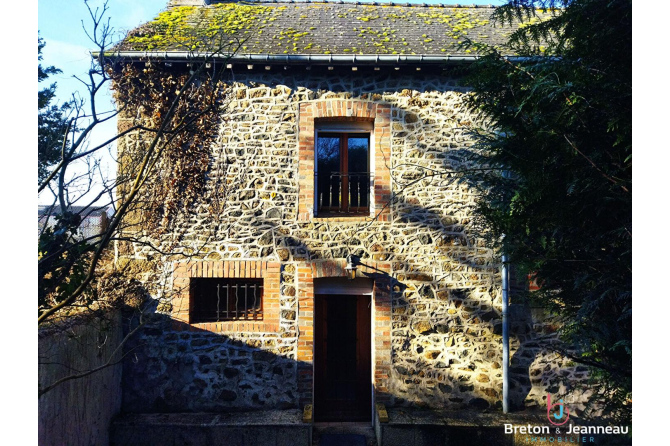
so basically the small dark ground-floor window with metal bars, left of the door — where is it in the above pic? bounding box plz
[191,278,263,323]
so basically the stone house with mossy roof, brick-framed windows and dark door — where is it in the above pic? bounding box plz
[114,0,586,420]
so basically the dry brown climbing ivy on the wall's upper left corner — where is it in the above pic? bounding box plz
[113,63,229,233]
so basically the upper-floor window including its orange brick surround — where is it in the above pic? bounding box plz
[296,103,391,222]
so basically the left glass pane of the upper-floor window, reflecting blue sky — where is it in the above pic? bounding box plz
[316,136,341,207]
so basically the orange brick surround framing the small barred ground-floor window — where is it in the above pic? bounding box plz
[172,260,280,333]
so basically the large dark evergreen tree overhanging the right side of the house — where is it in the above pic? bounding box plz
[469,0,632,419]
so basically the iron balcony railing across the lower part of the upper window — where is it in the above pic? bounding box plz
[316,172,371,214]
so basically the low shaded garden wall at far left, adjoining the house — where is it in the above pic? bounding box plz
[38,314,123,446]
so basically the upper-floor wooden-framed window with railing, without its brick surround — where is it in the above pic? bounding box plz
[315,122,371,217]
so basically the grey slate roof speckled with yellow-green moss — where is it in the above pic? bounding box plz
[115,0,552,56]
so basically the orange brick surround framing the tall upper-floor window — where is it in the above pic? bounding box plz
[298,99,391,221]
